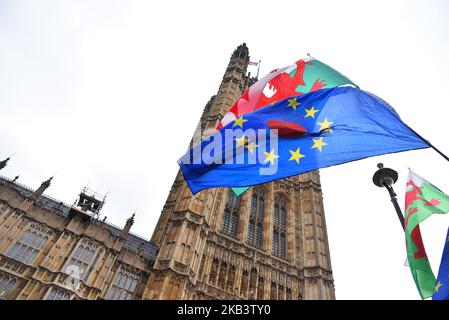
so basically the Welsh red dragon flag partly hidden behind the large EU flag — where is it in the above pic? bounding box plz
[217,58,356,195]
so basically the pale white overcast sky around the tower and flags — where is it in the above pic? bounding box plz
[0,0,449,299]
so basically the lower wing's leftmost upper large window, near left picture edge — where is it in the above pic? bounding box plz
[6,225,48,264]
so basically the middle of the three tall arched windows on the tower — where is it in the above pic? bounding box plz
[247,188,265,247]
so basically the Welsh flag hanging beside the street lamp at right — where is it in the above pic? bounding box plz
[405,170,449,299]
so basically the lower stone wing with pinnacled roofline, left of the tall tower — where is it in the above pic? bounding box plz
[0,172,157,300]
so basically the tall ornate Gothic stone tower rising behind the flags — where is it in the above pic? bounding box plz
[144,44,335,299]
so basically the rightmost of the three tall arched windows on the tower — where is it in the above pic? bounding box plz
[272,196,287,259]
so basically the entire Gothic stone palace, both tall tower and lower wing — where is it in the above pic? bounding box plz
[0,44,335,300]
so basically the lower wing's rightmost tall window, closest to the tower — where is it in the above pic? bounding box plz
[107,266,139,300]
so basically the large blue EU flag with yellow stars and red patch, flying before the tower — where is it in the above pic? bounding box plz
[178,87,429,194]
